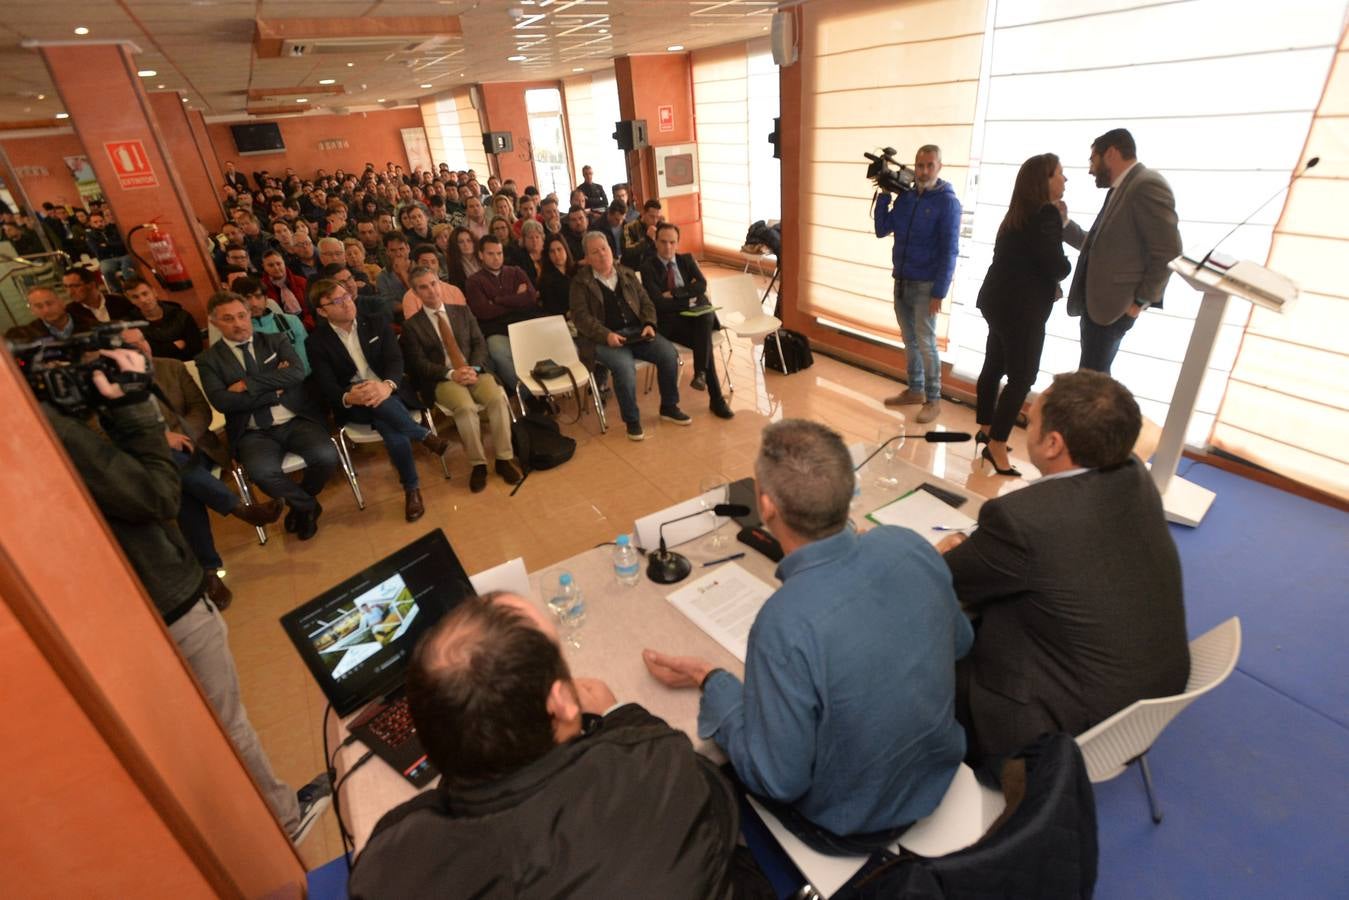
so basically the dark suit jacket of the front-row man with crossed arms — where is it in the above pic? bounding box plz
[197,332,324,452]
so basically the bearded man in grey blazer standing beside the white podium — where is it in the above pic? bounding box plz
[1059,128,1180,375]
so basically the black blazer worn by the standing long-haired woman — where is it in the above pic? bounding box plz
[977,204,1070,324]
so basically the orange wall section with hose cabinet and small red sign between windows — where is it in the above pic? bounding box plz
[614,53,703,256]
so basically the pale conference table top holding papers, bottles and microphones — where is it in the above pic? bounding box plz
[324,445,983,853]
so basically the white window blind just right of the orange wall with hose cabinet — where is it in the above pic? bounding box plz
[692,40,782,254]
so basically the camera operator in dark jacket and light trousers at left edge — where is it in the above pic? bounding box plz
[40,348,329,843]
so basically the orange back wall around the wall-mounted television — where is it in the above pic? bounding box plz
[206,107,422,184]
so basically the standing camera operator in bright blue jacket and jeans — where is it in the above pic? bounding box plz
[876,144,960,424]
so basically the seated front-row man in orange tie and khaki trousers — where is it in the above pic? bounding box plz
[399,266,523,494]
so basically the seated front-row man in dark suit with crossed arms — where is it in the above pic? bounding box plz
[197,291,337,541]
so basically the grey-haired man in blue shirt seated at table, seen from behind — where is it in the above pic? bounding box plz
[642,420,974,853]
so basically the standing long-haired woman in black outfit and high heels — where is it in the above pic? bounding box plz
[974,152,1070,476]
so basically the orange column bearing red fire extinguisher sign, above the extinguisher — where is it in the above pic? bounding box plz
[39,43,217,322]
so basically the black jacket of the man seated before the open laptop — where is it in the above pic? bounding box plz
[348,704,739,900]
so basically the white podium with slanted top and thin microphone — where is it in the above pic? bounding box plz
[1152,256,1298,528]
